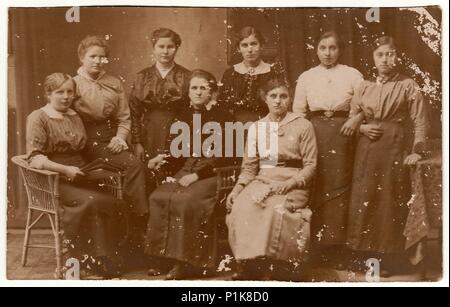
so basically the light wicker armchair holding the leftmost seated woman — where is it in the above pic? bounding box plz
[11,155,123,278]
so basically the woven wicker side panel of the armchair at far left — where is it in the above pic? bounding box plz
[11,155,59,214]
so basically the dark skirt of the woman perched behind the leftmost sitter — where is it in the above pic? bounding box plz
[83,121,148,216]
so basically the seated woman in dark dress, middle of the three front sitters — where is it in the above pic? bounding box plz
[145,70,225,279]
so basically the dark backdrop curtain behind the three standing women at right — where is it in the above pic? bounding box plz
[228,6,442,138]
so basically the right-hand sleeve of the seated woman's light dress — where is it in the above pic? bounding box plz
[293,120,317,188]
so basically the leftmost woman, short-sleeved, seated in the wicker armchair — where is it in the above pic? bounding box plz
[26,73,124,277]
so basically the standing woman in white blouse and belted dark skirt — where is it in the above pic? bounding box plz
[293,31,363,268]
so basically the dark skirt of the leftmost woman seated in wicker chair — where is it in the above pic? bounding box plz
[59,181,125,257]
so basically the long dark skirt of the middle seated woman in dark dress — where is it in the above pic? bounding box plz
[145,169,216,268]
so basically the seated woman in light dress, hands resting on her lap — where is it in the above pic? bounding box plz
[227,80,317,279]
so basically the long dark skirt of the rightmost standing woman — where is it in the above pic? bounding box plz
[348,122,411,253]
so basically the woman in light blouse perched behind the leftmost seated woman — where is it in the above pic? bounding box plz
[74,36,148,248]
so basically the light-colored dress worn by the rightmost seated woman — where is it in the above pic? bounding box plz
[226,113,317,261]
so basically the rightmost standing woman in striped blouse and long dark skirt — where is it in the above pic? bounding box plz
[348,36,427,275]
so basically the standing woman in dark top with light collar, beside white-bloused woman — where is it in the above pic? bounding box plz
[218,26,285,123]
